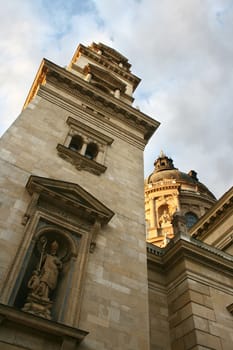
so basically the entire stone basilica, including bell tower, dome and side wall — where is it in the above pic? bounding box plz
[0,43,233,350]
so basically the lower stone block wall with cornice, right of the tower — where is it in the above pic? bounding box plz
[149,237,233,350]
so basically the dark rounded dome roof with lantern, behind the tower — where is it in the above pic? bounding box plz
[145,152,216,199]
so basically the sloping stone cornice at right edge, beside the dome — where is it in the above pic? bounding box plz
[189,187,233,239]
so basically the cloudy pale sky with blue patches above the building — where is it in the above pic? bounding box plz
[0,0,233,197]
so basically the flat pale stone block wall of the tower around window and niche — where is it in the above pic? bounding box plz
[0,85,149,350]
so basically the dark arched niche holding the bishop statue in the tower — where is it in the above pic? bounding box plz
[14,225,80,320]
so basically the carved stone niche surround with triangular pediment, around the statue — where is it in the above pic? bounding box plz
[1,176,114,326]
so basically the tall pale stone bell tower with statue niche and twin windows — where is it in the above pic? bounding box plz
[0,43,159,350]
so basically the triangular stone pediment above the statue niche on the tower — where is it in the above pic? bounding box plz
[26,175,114,224]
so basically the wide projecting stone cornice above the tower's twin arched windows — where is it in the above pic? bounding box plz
[24,59,160,141]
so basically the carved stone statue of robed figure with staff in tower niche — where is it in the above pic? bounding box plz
[22,237,62,319]
